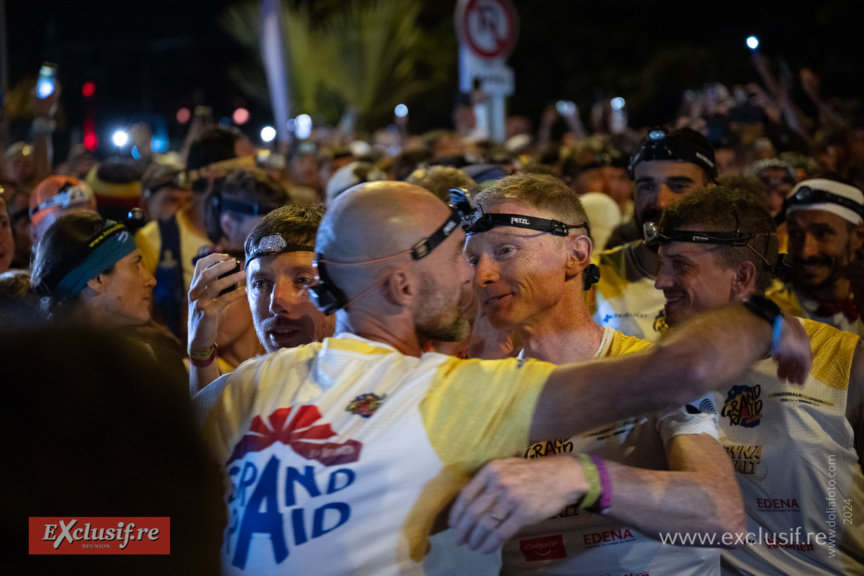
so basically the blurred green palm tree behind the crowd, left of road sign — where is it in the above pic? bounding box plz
[222,0,452,129]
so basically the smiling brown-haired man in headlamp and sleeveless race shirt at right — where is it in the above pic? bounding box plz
[655,187,864,576]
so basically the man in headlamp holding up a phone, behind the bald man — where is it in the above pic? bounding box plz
[189,205,335,394]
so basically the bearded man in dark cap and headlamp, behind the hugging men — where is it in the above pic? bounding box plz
[591,128,717,340]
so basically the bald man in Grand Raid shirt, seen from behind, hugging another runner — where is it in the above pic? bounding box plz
[195,182,810,575]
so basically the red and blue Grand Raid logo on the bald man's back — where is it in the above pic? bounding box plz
[225,406,363,569]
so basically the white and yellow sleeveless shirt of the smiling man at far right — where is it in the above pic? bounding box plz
[717,320,864,576]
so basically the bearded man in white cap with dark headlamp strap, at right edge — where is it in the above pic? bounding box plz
[767,178,864,336]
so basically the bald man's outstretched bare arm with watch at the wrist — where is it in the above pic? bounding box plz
[530,305,812,438]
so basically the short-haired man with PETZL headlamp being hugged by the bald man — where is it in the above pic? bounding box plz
[465,174,744,576]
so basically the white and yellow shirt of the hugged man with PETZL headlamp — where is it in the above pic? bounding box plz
[501,328,720,576]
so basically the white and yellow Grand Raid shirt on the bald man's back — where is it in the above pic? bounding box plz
[194,334,554,576]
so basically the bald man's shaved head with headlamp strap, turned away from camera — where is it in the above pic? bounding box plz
[316,181,471,340]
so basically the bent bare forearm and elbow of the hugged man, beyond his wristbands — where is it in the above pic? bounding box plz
[606,434,747,547]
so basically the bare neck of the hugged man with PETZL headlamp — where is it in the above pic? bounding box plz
[516,294,604,364]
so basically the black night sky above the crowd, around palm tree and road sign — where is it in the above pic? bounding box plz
[5,0,864,152]
